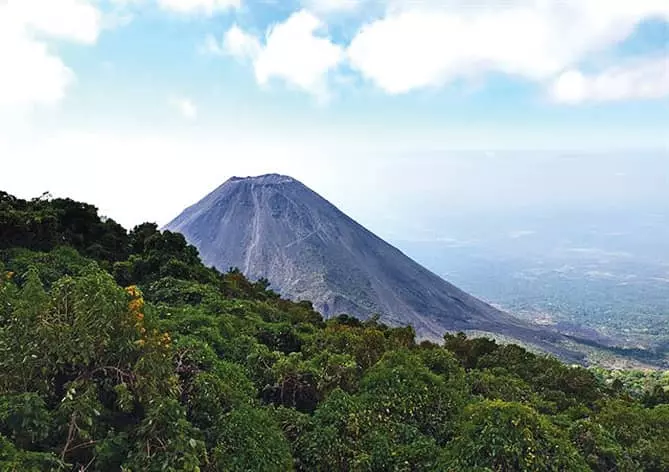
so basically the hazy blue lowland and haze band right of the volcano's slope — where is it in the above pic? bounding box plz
[326,150,669,364]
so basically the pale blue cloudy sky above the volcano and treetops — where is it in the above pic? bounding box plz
[0,0,669,231]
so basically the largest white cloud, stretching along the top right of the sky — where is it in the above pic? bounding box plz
[347,0,669,94]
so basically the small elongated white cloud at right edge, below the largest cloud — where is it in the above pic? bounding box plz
[550,57,669,104]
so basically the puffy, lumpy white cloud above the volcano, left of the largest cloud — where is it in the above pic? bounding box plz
[223,10,344,98]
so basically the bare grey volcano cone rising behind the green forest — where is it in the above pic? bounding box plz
[165,174,576,353]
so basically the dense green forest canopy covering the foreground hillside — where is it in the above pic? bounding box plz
[0,193,669,472]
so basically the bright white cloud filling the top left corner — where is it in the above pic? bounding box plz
[0,0,101,111]
